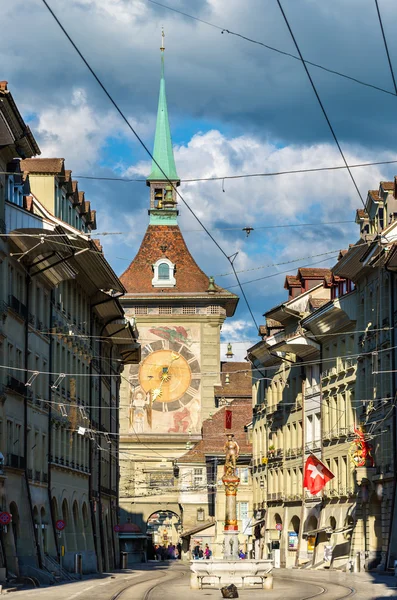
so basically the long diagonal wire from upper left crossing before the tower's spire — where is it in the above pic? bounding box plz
[42,0,258,329]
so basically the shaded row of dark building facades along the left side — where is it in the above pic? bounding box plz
[0,84,139,582]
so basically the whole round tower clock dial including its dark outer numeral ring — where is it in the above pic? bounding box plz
[138,341,200,412]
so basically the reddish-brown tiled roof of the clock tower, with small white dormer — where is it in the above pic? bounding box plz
[120,225,237,301]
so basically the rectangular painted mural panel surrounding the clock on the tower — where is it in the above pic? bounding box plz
[124,323,201,434]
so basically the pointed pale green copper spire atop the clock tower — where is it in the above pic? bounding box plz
[147,44,179,181]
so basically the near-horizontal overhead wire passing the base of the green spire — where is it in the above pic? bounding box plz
[0,160,397,183]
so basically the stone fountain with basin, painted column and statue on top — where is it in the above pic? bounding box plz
[190,433,273,589]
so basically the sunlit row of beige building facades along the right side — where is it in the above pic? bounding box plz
[249,182,397,569]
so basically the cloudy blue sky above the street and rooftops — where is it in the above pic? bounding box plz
[0,0,397,359]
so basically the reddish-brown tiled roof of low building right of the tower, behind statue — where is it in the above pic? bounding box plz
[178,398,252,463]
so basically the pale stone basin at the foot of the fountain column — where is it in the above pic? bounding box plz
[190,559,273,590]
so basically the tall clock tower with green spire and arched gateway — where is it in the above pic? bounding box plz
[119,38,238,544]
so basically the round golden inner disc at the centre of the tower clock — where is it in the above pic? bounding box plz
[138,349,192,410]
